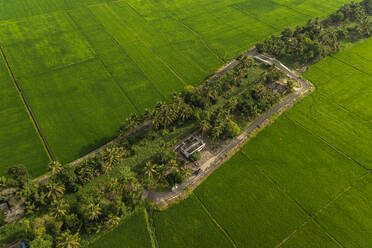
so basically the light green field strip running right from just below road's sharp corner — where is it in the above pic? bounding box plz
[287,91,372,168]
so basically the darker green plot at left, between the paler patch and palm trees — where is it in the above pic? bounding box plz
[17,59,134,162]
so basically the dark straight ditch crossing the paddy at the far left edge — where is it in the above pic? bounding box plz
[0,45,55,161]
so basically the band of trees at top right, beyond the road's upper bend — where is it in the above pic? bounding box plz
[256,0,372,64]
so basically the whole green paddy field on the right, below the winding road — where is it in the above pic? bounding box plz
[91,36,372,248]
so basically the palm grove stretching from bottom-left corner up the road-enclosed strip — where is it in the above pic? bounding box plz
[0,43,283,248]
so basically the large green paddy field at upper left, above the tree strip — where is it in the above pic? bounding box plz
[0,0,358,176]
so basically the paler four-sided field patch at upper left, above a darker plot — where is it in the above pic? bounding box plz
[0,12,94,78]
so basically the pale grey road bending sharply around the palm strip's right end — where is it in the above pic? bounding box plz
[147,48,311,205]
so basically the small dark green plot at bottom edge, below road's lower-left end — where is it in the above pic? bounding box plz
[153,195,232,248]
